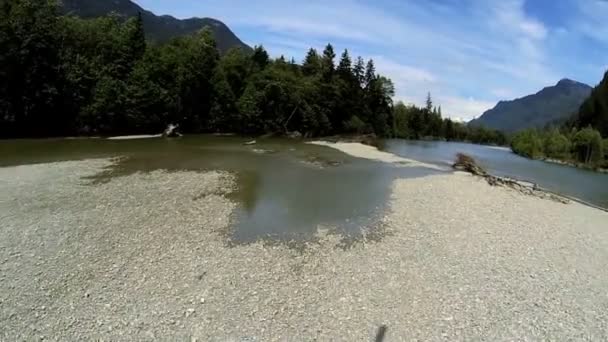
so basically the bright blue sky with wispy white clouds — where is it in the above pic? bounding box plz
[135,0,608,121]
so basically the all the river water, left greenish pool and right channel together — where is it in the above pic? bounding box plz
[0,136,608,243]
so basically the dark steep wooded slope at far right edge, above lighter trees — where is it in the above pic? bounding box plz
[574,71,608,138]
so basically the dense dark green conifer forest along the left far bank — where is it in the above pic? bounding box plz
[0,0,506,144]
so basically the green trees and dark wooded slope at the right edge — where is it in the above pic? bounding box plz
[511,72,608,168]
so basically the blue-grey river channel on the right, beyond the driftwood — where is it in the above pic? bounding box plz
[383,140,608,208]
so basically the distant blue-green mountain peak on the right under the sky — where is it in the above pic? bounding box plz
[469,79,592,133]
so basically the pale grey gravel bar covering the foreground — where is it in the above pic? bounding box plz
[0,160,608,341]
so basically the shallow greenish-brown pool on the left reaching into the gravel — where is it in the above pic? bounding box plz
[0,136,431,242]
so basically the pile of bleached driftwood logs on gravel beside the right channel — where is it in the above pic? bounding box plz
[452,153,570,204]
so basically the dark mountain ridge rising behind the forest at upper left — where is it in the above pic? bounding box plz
[62,0,251,52]
